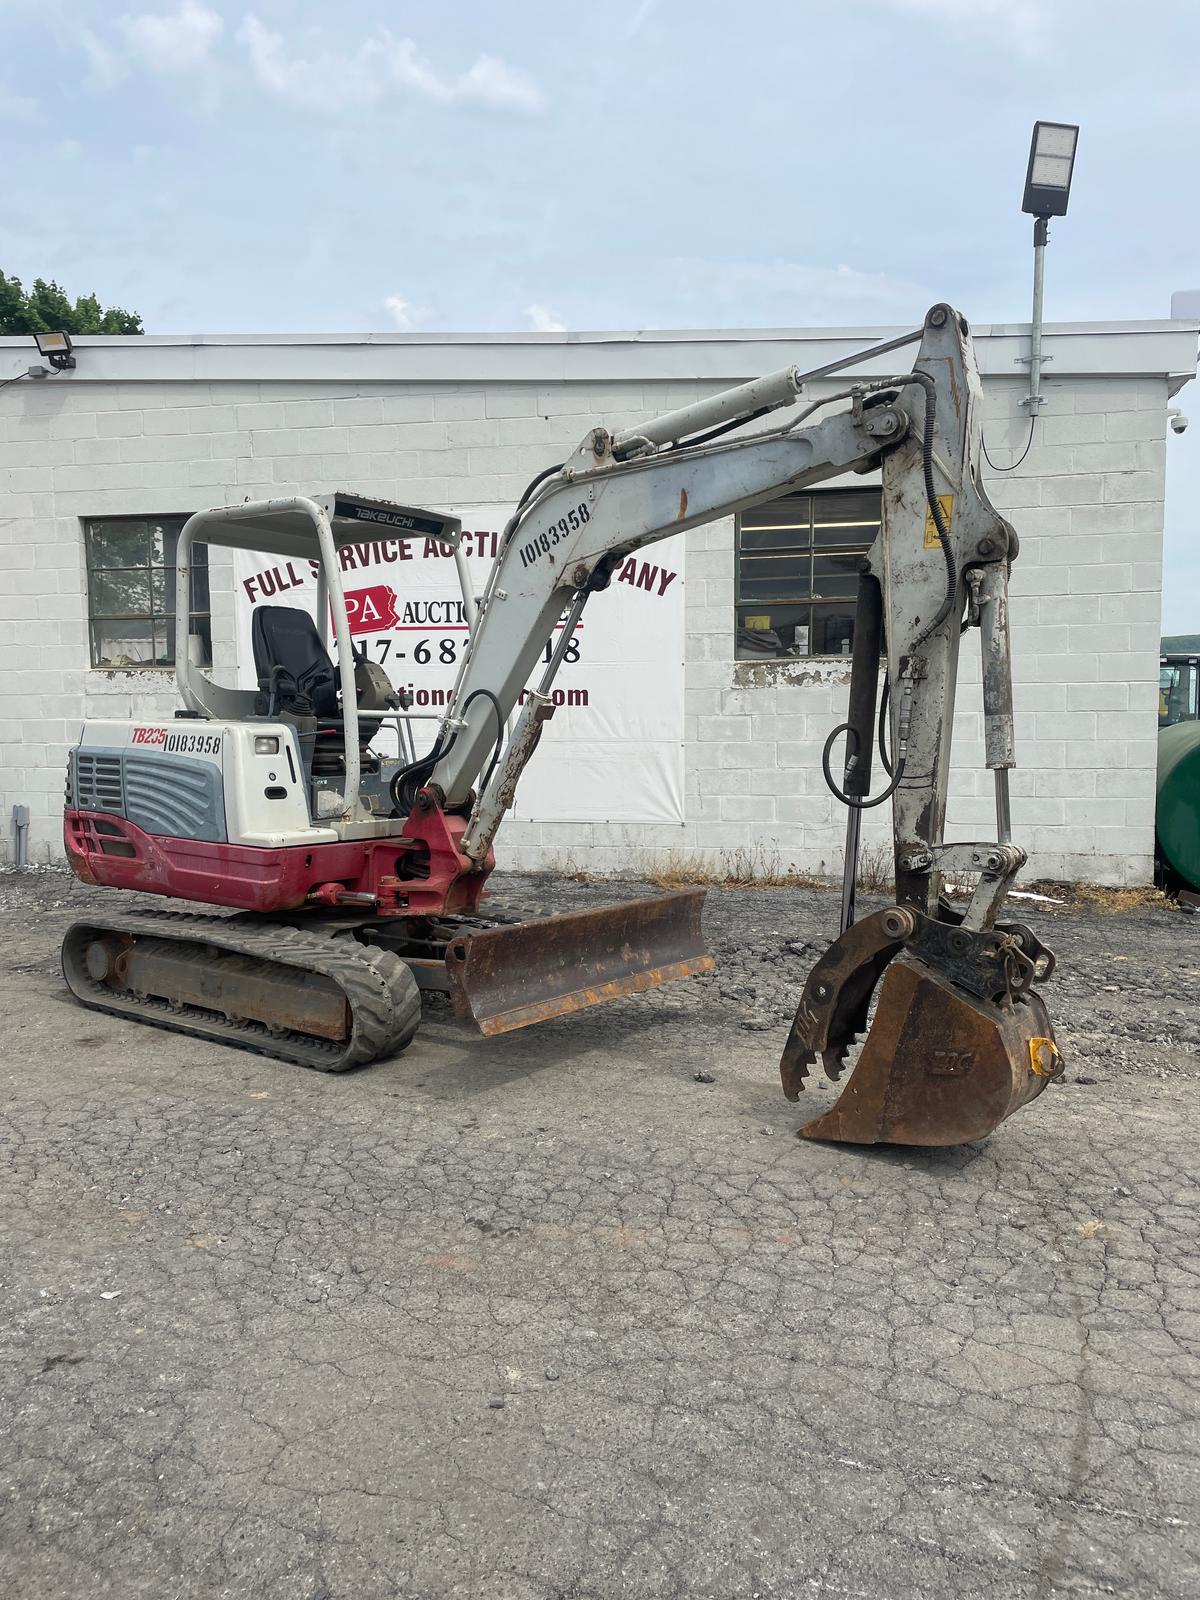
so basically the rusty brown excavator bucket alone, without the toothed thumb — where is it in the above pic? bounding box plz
[800,957,1062,1146]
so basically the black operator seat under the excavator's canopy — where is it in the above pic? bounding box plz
[250,605,379,774]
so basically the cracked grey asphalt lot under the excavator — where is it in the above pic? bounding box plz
[0,872,1200,1600]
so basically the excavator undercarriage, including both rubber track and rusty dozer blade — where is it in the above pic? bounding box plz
[62,890,715,1072]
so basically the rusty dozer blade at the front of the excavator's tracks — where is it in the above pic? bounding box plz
[446,890,715,1034]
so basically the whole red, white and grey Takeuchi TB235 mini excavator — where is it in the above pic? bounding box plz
[62,306,1061,1146]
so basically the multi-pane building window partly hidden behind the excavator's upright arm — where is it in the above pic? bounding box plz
[736,488,880,661]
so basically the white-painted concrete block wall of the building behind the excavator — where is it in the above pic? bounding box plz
[0,363,1168,883]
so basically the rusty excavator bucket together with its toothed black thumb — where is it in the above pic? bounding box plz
[781,907,1062,1146]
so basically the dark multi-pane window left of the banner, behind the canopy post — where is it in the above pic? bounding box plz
[83,517,213,667]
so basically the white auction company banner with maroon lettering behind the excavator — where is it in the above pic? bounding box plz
[234,506,683,822]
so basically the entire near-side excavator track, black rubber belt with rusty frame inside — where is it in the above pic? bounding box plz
[62,912,421,1072]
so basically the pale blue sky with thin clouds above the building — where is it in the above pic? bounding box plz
[0,0,1200,632]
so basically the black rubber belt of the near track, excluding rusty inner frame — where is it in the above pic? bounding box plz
[62,912,421,1072]
